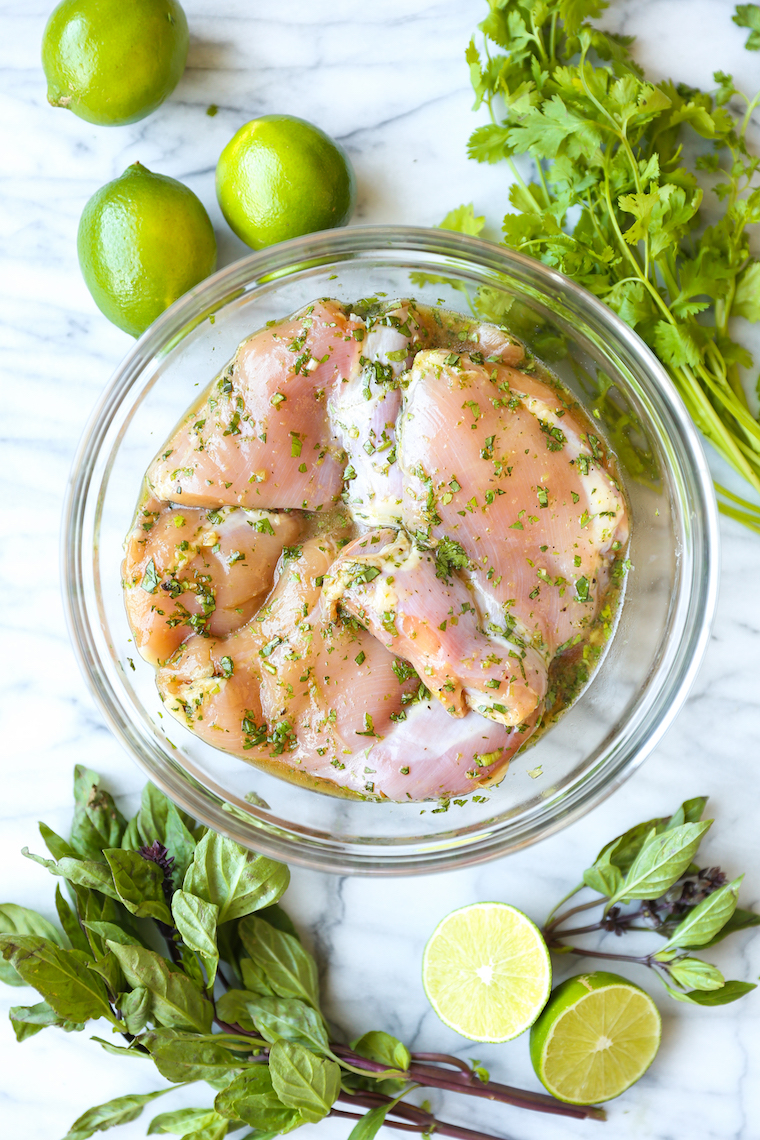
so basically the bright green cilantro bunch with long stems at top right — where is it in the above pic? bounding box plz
[451,0,760,531]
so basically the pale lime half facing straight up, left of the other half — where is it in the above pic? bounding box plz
[423,903,551,1041]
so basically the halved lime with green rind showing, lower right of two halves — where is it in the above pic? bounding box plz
[531,970,661,1105]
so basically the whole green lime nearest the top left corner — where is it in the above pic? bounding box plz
[42,0,188,127]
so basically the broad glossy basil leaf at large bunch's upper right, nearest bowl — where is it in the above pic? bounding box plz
[182,831,289,923]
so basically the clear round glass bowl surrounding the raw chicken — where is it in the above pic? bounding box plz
[63,226,718,874]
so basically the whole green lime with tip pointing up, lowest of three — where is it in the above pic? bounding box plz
[76,162,216,336]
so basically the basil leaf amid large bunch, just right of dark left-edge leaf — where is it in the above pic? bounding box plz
[106,941,214,1033]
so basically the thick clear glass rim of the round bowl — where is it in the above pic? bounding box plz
[60,225,719,876]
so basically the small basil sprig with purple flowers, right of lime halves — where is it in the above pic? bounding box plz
[544,796,760,1005]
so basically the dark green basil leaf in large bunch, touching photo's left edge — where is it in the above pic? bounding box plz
[0,934,115,1023]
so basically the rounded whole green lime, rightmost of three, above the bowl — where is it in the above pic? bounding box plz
[216,115,357,250]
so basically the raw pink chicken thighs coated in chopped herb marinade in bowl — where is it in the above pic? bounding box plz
[123,300,628,801]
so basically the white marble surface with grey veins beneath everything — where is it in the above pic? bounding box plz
[0,0,760,1140]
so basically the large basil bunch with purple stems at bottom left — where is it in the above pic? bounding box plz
[0,767,604,1140]
